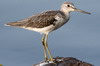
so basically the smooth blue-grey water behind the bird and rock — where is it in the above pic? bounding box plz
[0,0,100,66]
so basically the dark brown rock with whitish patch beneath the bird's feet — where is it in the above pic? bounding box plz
[33,57,93,66]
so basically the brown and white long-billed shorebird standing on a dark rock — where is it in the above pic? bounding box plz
[6,2,90,61]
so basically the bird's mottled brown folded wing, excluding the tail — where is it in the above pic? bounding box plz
[25,11,57,28]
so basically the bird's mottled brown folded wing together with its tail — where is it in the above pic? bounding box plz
[7,11,63,28]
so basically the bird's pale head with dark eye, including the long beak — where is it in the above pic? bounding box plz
[61,2,91,14]
